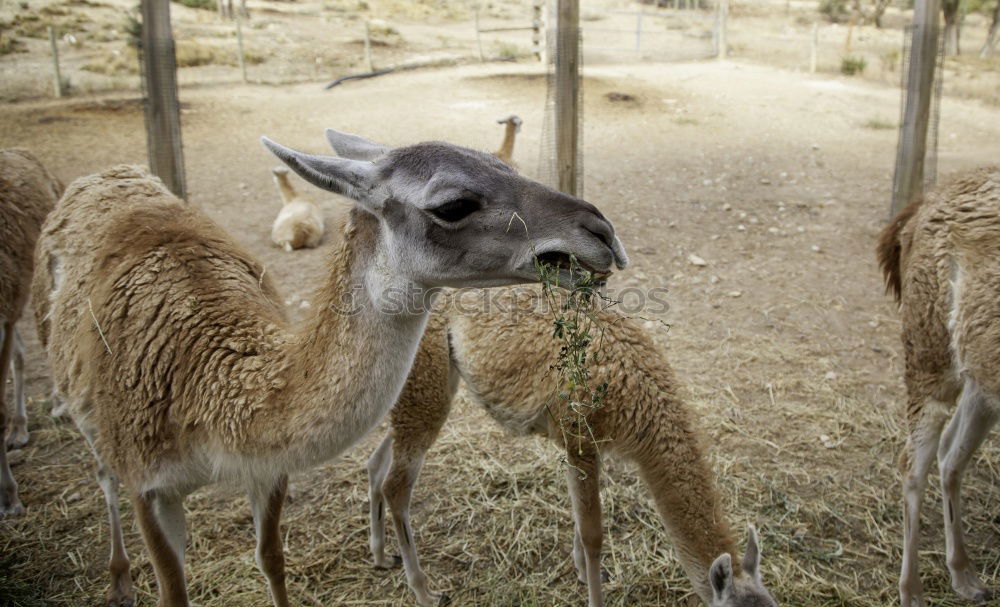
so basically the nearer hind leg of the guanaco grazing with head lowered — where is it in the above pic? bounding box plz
[382,449,447,607]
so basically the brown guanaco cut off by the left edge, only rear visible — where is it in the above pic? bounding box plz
[0,149,62,518]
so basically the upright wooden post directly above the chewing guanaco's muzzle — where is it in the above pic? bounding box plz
[555,0,580,196]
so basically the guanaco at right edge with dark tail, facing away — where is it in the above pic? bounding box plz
[878,167,1000,607]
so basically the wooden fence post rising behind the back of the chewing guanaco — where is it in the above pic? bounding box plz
[142,0,187,198]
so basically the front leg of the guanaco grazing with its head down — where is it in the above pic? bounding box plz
[566,448,604,607]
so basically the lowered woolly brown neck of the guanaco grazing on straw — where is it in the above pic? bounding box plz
[633,416,740,604]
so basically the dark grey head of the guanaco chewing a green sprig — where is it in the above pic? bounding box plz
[264,130,627,287]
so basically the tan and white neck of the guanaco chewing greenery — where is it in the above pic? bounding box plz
[250,210,428,471]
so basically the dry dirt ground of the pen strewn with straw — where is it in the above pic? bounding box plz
[0,4,1000,607]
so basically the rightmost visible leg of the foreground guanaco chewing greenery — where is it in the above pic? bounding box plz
[250,476,288,607]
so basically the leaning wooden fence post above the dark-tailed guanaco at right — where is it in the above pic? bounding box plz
[889,0,941,215]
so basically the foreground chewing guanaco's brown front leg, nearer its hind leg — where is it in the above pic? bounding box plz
[132,493,189,607]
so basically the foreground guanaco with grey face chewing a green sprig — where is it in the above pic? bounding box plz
[33,131,624,607]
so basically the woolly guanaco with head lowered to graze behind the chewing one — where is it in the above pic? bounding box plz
[368,293,776,607]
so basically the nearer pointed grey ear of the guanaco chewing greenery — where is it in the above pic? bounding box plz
[260,137,384,211]
